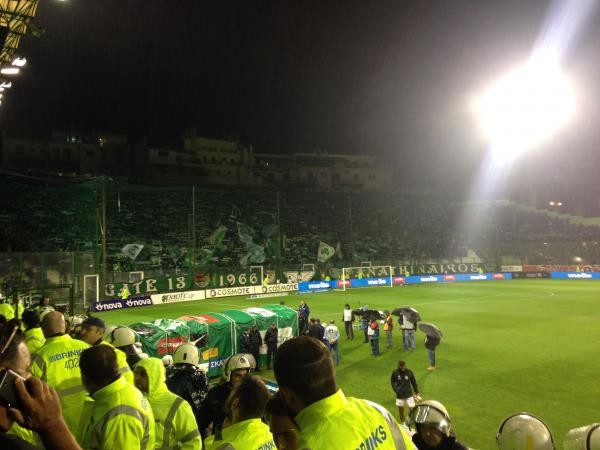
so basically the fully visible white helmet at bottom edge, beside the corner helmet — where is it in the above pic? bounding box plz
[496,413,556,450]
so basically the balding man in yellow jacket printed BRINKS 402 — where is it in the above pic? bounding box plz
[31,311,89,434]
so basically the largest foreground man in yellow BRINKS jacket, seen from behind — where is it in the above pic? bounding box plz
[274,336,414,450]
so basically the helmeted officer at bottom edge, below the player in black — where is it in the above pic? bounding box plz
[410,400,468,450]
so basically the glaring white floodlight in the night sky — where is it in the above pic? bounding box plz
[477,61,574,156]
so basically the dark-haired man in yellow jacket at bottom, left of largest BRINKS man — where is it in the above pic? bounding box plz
[204,375,275,450]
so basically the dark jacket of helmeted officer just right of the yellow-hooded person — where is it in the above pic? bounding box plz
[167,364,208,424]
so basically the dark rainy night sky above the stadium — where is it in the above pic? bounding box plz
[0,0,600,187]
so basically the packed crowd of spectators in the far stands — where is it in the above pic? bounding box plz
[0,176,600,272]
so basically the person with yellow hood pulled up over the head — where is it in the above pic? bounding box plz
[134,356,202,450]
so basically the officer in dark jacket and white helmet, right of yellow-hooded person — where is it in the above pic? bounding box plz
[166,343,208,426]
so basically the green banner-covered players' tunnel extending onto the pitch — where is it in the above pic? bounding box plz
[129,305,298,377]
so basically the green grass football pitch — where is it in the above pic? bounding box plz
[94,280,600,450]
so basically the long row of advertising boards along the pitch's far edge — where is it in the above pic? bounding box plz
[92,272,600,312]
